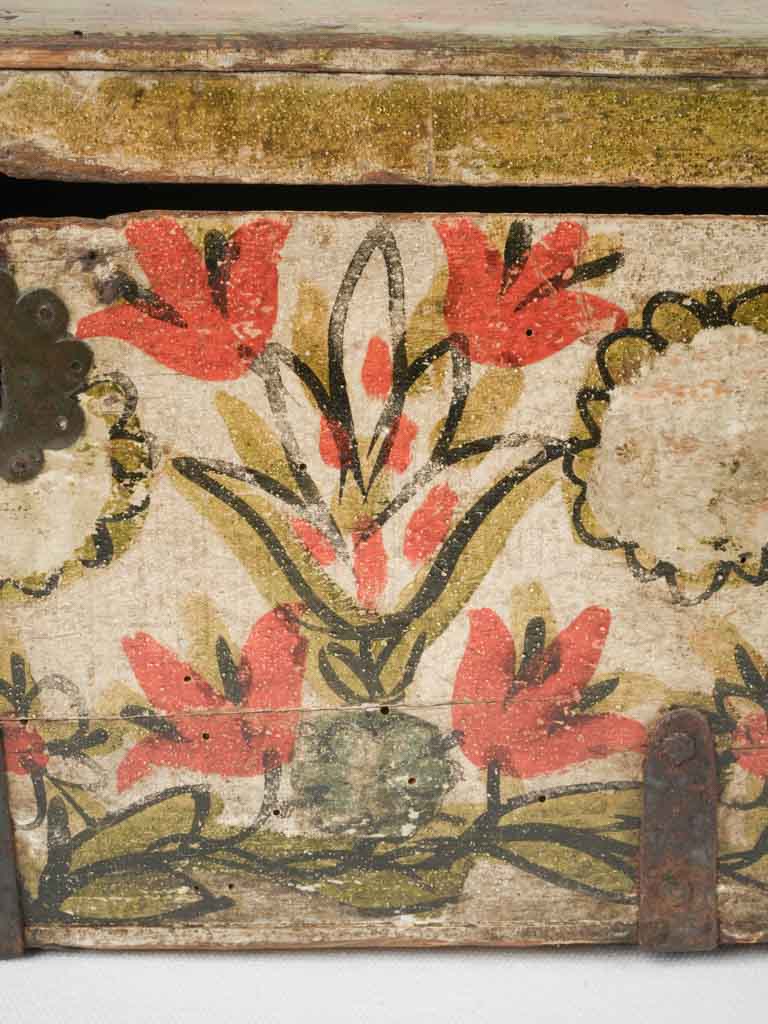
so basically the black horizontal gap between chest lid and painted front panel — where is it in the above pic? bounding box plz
[0,175,768,219]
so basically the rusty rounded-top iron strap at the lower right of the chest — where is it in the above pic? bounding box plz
[639,709,718,952]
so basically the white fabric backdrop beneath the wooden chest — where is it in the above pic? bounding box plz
[0,948,768,1024]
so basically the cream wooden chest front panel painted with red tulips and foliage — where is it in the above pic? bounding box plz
[0,213,768,947]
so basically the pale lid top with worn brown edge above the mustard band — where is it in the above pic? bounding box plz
[0,0,768,76]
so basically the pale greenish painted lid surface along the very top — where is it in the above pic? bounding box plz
[3,0,765,40]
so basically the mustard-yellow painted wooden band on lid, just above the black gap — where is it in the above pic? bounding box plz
[0,72,768,185]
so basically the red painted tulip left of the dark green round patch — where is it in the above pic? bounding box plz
[118,607,306,790]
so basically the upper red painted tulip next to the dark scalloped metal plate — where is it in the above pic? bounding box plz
[77,217,289,380]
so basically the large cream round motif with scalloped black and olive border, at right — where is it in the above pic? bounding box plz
[563,288,768,604]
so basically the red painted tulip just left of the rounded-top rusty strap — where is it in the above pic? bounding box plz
[454,607,645,778]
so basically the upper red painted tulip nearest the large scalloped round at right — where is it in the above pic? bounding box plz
[435,217,627,367]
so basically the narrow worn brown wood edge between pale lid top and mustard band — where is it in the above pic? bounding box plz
[0,32,768,78]
